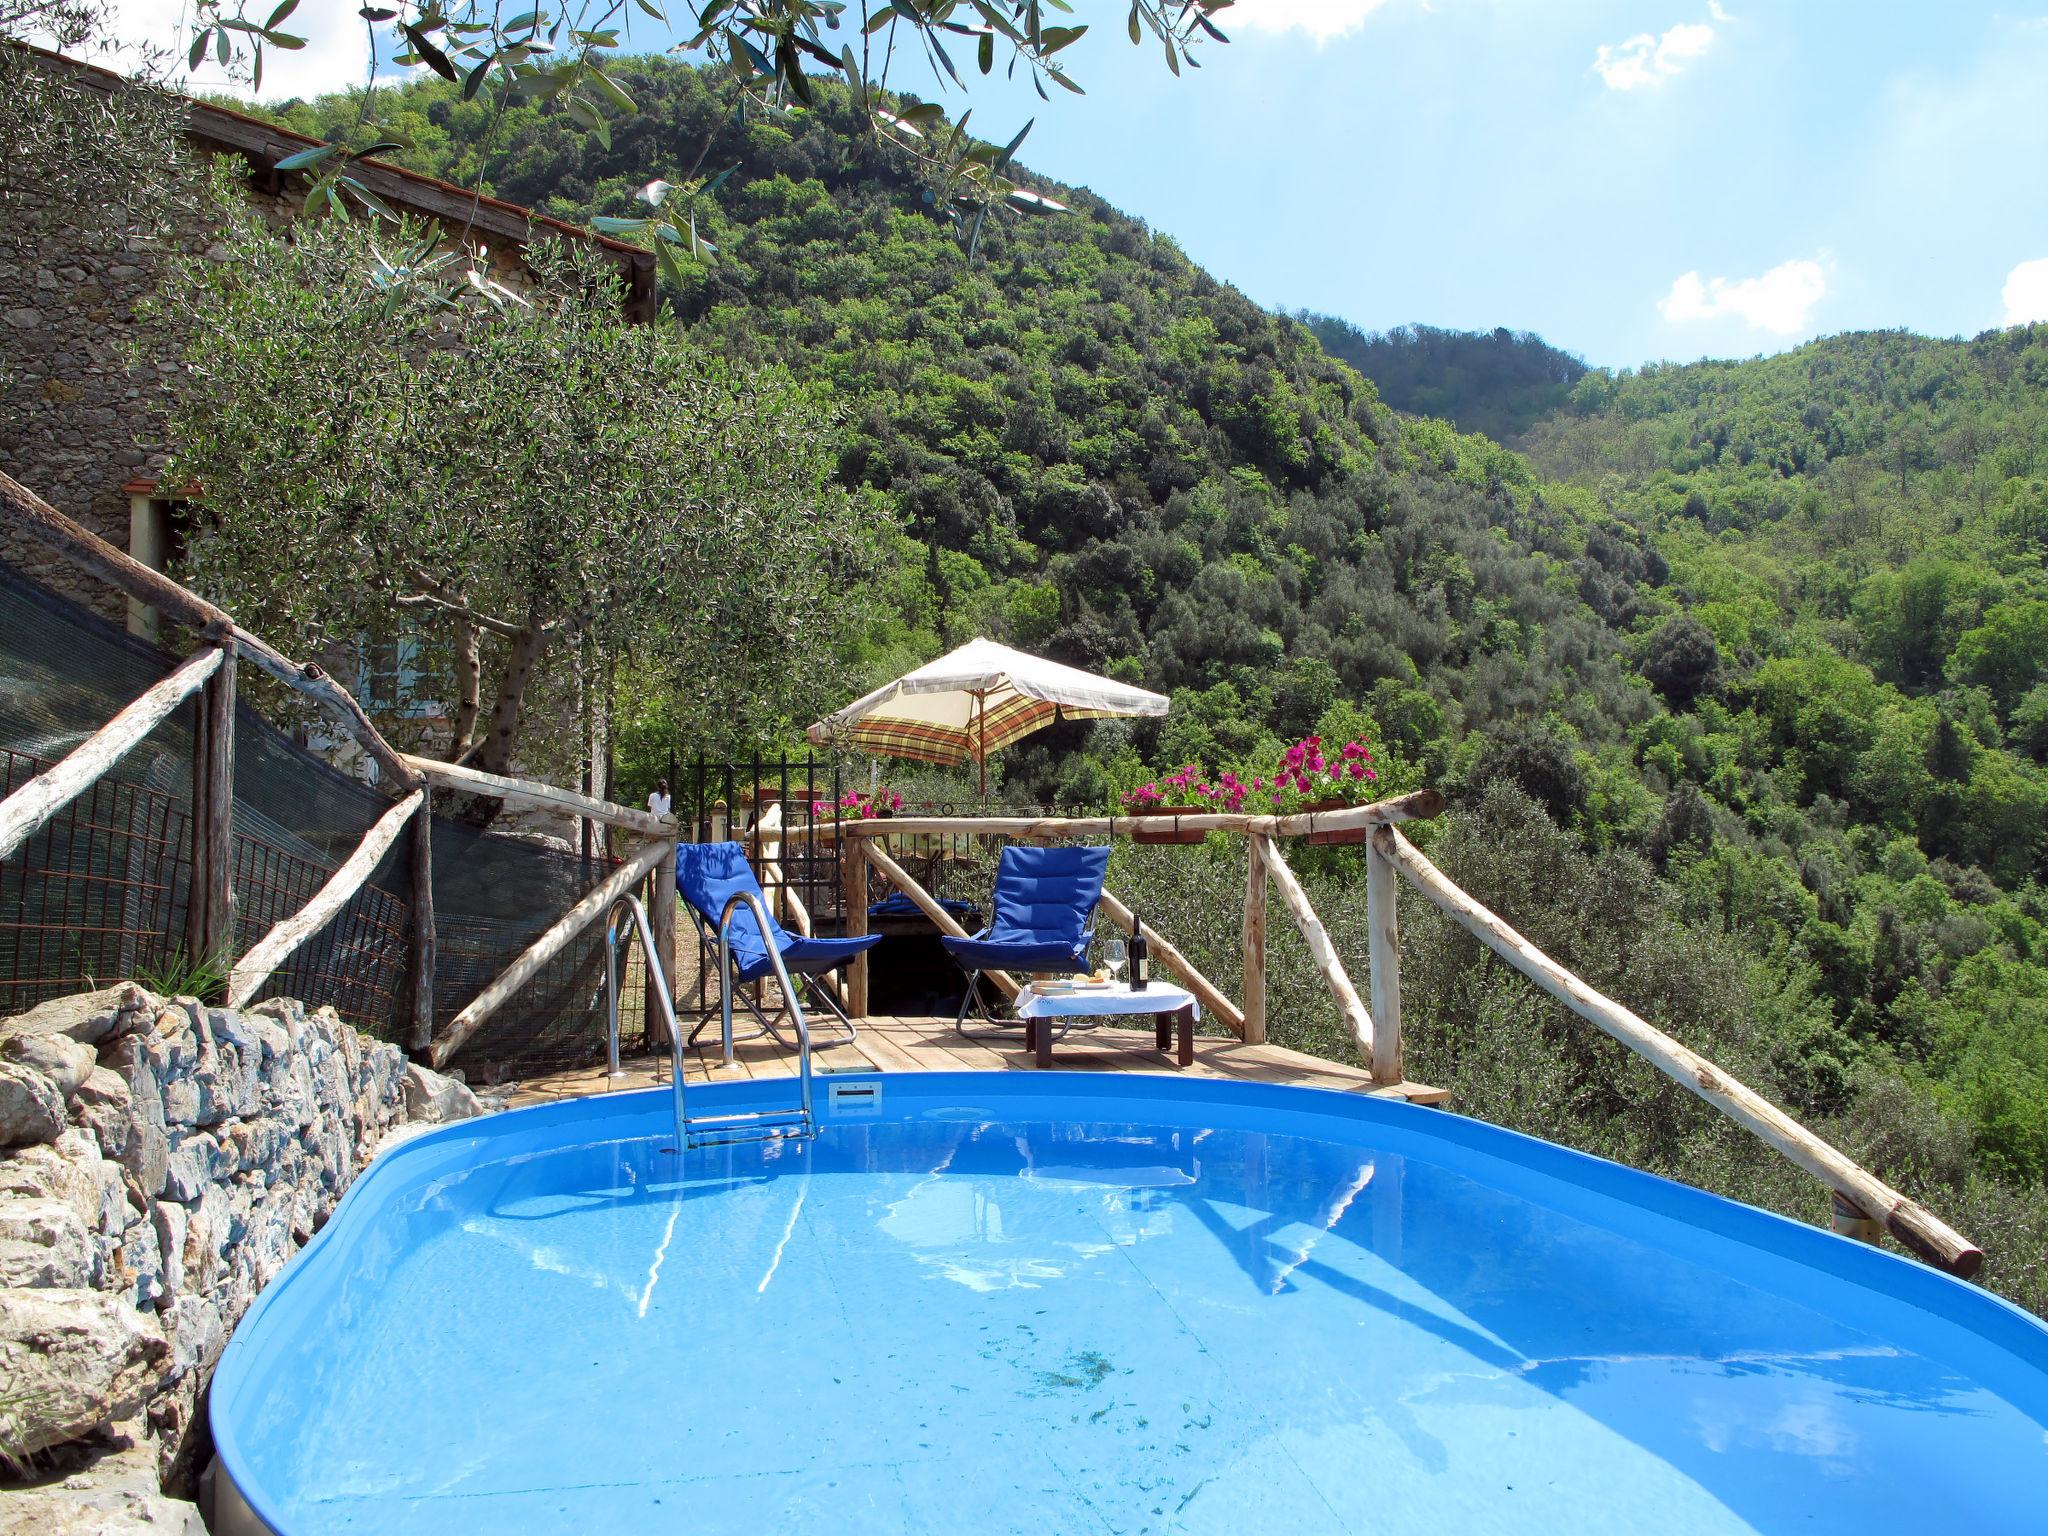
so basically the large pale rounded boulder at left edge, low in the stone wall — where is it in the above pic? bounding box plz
[0,1290,170,1454]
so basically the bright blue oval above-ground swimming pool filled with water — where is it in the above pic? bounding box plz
[213,1073,2048,1536]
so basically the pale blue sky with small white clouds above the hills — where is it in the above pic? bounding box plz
[103,0,2048,367]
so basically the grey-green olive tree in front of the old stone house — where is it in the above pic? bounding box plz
[144,196,889,798]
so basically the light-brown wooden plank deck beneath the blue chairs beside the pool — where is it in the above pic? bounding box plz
[494,1014,1448,1108]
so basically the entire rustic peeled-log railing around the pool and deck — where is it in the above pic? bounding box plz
[0,475,1985,1276]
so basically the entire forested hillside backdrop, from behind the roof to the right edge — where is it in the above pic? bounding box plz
[243,63,2048,1305]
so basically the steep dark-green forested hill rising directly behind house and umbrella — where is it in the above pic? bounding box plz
[260,63,1661,799]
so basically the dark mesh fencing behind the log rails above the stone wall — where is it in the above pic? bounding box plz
[0,565,610,1079]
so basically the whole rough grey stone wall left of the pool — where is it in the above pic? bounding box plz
[0,985,481,1536]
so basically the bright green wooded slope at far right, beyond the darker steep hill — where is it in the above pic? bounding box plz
[1524,326,2048,1180]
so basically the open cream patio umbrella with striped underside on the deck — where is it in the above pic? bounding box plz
[809,639,1167,795]
